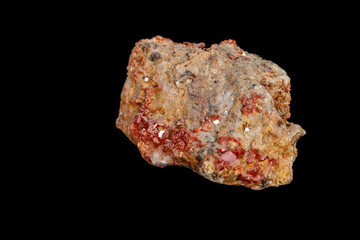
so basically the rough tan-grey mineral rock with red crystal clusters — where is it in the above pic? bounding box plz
[116,36,305,189]
